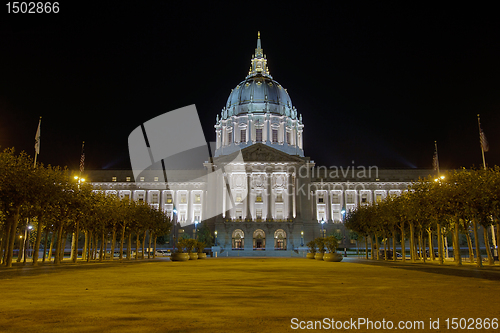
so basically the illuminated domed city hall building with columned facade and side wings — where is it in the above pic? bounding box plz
[86,36,431,256]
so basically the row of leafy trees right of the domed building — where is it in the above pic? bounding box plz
[346,167,500,266]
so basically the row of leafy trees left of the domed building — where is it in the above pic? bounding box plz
[0,149,171,267]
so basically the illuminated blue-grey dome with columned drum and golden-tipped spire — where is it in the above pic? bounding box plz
[215,33,304,157]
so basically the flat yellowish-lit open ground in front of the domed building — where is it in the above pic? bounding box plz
[0,258,500,333]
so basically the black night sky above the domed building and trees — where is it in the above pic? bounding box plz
[0,1,500,169]
